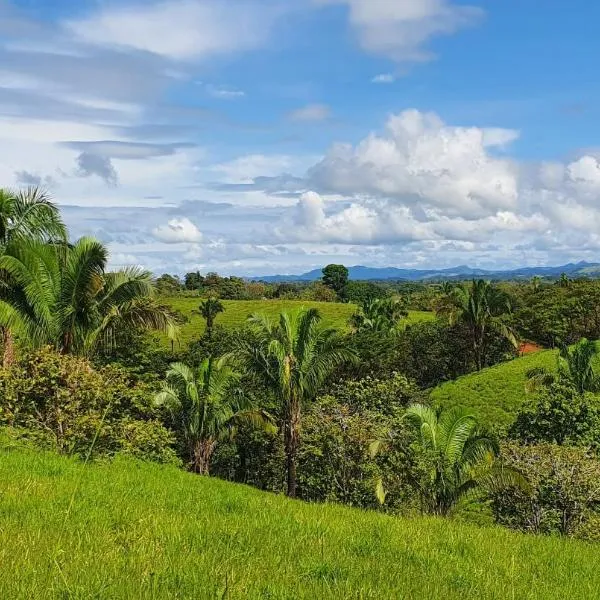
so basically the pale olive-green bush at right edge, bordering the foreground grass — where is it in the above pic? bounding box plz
[492,444,600,539]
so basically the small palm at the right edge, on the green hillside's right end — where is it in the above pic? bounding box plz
[526,338,600,394]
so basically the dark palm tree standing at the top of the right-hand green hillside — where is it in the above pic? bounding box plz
[438,279,518,371]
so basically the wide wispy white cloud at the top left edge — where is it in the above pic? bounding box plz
[66,0,274,60]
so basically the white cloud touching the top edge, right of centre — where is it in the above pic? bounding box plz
[313,0,483,62]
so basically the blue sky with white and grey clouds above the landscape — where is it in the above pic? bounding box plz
[0,0,600,275]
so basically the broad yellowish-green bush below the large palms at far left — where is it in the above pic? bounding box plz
[0,348,178,463]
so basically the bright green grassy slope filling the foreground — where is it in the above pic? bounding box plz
[0,442,600,600]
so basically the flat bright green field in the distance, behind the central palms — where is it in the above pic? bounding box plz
[162,296,434,347]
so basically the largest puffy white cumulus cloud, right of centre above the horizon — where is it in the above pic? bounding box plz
[308,110,518,218]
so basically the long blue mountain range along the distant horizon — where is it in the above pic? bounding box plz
[250,261,600,283]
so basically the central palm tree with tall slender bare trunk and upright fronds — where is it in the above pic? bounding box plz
[238,309,356,498]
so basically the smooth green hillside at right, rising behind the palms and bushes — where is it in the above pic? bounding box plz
[431,350,556,427]
